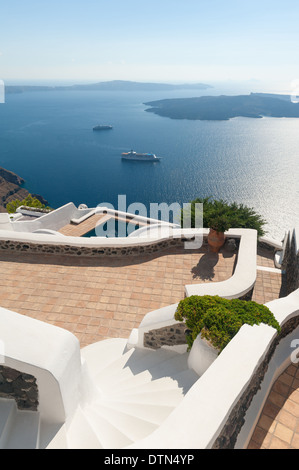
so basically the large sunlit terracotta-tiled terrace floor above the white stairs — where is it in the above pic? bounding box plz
[0,247,235,347]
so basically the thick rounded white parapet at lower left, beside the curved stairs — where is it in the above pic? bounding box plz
[0,307,81,424]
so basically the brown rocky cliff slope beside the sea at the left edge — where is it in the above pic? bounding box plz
[0,167,49,212]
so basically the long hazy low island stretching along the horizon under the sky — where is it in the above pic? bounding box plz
[5,80,212,93]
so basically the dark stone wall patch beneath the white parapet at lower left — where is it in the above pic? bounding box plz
[0,366,38,411]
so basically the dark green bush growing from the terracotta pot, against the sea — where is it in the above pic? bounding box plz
[181,197,266,236]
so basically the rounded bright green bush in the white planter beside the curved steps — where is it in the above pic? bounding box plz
[175,295,280,351]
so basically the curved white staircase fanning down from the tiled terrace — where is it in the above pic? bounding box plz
[48,338,199,449]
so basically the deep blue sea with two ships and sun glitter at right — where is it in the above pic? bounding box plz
[0,85,299,238]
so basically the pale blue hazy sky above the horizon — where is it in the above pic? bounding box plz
[0,0,299,88]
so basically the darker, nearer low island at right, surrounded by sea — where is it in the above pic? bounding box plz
[144,93,299,120]
